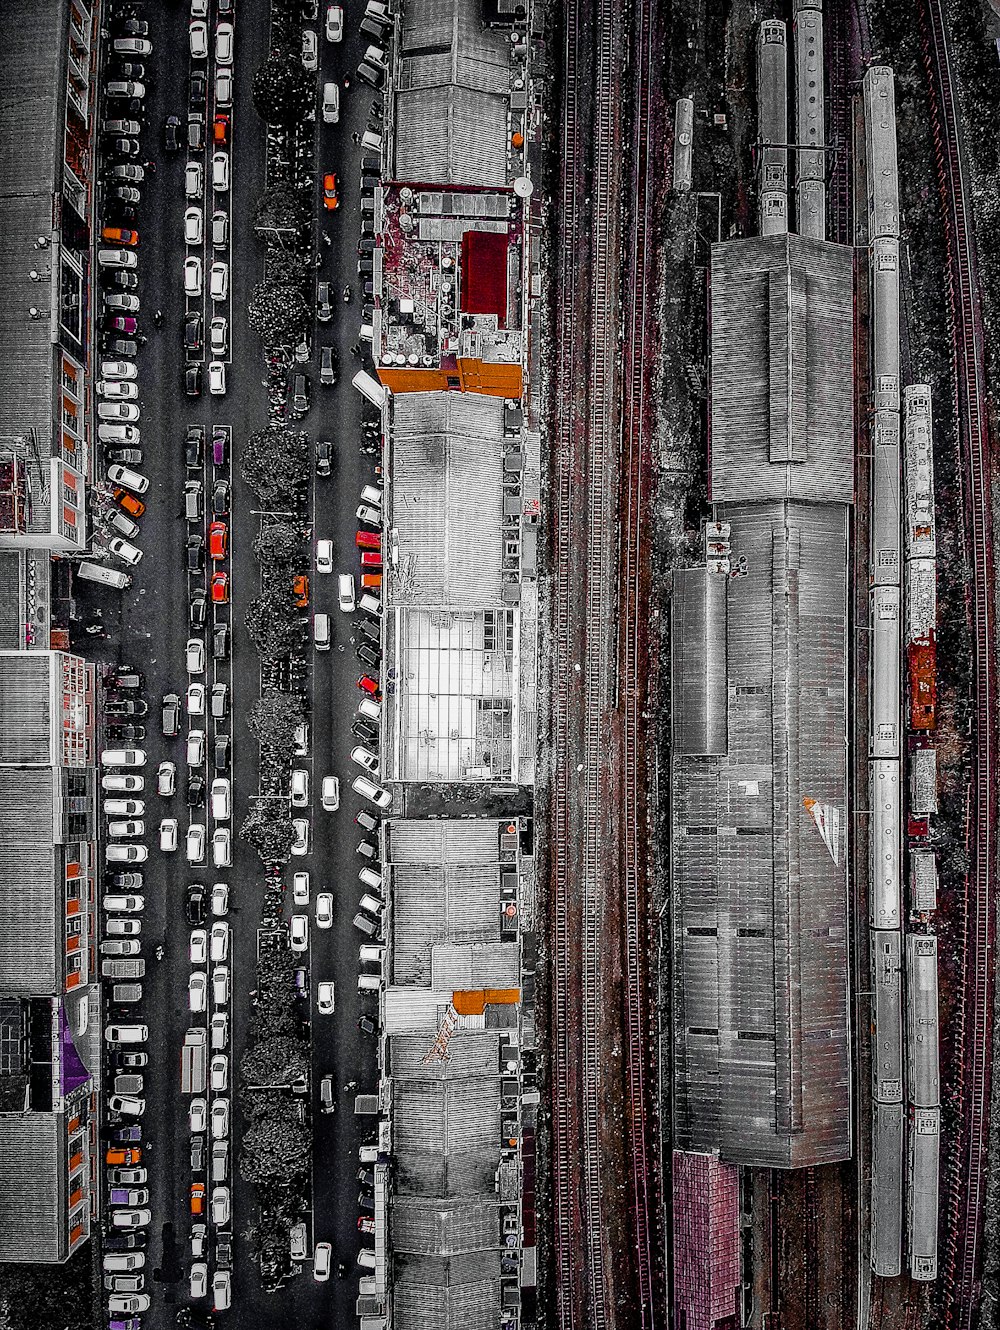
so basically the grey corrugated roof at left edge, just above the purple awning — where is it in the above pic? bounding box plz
[0,767,63,996]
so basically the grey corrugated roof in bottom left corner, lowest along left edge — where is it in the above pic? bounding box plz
[0,1113,68,1262]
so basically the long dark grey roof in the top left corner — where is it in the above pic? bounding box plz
[0,0,66,452]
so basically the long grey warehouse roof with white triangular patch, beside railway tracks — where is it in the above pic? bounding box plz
[672,503,851,1168]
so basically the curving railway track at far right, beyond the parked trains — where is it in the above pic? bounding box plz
[920,0,996,1327]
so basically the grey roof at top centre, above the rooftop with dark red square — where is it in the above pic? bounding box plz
[394,0,511,189]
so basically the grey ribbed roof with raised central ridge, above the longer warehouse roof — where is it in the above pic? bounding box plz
[711,235,854,503]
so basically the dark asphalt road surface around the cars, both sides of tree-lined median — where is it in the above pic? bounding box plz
[77,0,376,1330]
